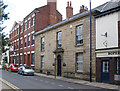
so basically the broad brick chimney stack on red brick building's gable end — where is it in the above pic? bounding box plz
[47,0,57,25]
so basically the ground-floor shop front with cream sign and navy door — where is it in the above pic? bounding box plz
[96,48,120,84]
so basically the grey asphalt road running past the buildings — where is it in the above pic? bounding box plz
[2,70,116,91]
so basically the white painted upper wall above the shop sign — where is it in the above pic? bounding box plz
[96,12,118,49]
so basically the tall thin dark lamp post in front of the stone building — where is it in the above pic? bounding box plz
[90,0,92,82]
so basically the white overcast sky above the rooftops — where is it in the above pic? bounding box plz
[3,0,110,33]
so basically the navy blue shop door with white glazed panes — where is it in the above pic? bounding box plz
[101,60,110,83]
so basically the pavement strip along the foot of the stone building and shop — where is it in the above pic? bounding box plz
[35,73,120,91]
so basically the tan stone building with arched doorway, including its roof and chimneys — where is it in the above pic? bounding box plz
[35,3,96,80]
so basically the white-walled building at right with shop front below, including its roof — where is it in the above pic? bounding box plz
[95,1,120,84]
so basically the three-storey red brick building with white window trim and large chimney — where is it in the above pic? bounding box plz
[9,0,62,67]
